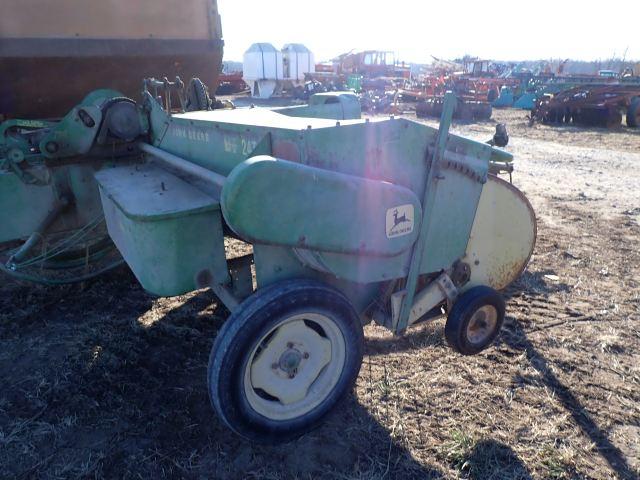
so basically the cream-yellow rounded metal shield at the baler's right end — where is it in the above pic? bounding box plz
[463,175,537,291]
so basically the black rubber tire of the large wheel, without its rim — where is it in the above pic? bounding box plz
[207,279,364,444]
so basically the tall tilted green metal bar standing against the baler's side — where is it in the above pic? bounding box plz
[394,92,457,335]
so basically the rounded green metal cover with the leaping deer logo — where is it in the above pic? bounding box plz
[222,156,422,256]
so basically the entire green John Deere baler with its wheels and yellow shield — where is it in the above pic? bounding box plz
[0,81,536,442]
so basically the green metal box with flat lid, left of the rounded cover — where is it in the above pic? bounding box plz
[96,165,229,296]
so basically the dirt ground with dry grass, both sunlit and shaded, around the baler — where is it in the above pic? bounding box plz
[0,110,640,480]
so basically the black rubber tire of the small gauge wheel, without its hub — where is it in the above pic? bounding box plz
[444,286,505,355]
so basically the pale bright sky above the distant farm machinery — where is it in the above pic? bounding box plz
[218,0,640,63]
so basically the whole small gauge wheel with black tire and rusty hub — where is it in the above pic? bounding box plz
[444,286,505,355]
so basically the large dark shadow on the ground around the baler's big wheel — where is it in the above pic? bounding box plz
[0,276,442,479]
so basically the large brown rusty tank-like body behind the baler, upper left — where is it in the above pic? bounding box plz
[0,0,223,118]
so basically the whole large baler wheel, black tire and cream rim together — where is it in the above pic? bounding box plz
[208,280,363,443]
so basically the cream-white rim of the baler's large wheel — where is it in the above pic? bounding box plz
[244,313,346,420]
